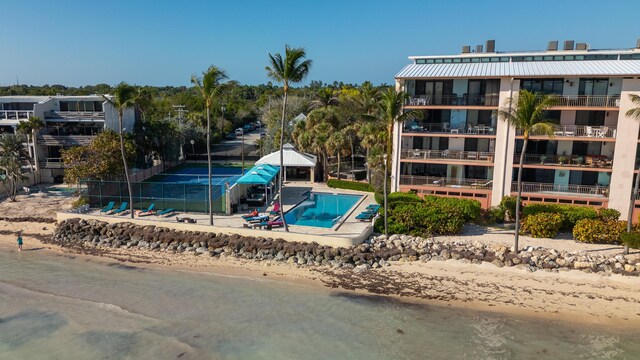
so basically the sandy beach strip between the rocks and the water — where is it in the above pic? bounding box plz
[0,221,640,329]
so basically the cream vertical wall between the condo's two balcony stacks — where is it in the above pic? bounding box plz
[491,78,520,206]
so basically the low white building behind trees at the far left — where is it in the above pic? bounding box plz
[0,95,135,182]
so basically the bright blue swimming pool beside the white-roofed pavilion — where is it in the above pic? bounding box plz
[284,193,362,228]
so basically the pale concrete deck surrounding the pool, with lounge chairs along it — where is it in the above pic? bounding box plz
[58,181,375,247]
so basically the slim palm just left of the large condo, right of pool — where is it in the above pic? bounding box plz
[378,88,417,236]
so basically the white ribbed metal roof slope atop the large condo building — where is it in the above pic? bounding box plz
[396,60,640,79]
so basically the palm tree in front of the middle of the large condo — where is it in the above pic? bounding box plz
[497,90,556,252]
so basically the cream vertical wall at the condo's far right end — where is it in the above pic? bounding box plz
[609,79,640,218]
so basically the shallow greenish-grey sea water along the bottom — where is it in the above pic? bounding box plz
[0,251,640,360]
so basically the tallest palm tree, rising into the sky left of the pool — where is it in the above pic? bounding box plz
[265,45,311,232]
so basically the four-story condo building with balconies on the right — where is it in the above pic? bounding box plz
[391,40,640,216]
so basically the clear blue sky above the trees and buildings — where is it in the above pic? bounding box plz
[0,0,640,86]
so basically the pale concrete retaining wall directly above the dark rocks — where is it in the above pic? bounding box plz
[56,212,373,247]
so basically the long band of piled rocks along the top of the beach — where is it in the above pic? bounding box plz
[51,219,640,276]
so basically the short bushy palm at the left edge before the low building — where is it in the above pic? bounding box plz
[0,134,29,201]
